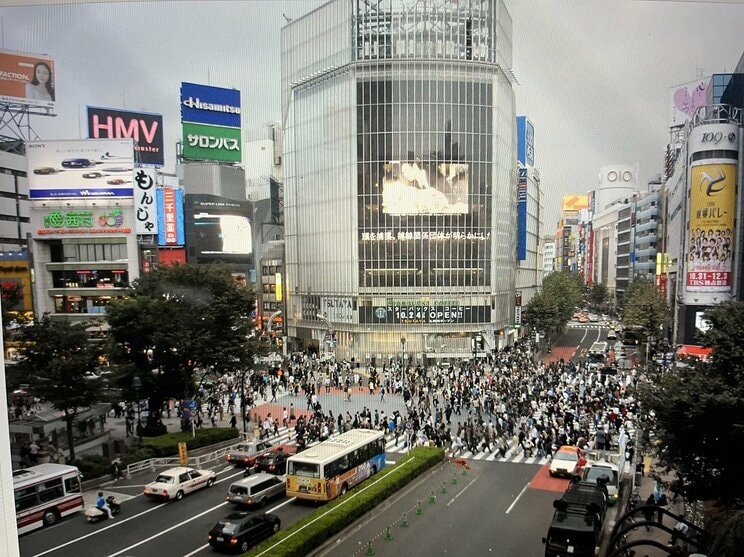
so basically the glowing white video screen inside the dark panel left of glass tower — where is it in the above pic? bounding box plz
[194,213,253,255]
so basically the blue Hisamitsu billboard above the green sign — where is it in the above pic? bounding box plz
[181,82,240,128]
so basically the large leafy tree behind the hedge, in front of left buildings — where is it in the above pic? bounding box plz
[107,265,257,431]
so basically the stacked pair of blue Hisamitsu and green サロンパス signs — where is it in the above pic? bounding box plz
[181,82,241,162]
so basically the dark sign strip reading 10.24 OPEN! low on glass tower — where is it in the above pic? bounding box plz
[359,302,491,324]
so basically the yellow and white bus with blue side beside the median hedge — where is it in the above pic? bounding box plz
[287,429,385,501]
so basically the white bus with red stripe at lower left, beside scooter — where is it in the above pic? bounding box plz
[13,464,85,534]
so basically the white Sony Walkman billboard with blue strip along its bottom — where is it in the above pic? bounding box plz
[26,139,134,199]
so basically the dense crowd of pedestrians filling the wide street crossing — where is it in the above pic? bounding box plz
[169,334,637,458]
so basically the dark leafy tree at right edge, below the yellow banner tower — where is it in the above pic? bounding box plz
[642,302,744,505]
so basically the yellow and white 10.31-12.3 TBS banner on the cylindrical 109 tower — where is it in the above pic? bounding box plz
[686,163,736,292]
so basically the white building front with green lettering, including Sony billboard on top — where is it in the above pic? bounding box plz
[27,140,139,321]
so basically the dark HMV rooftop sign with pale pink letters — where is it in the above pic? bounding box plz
[88,106,165,166]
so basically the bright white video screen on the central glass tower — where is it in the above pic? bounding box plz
[382,159,470,215]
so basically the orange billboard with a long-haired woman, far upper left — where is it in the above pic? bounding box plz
[0,50,57,108]
